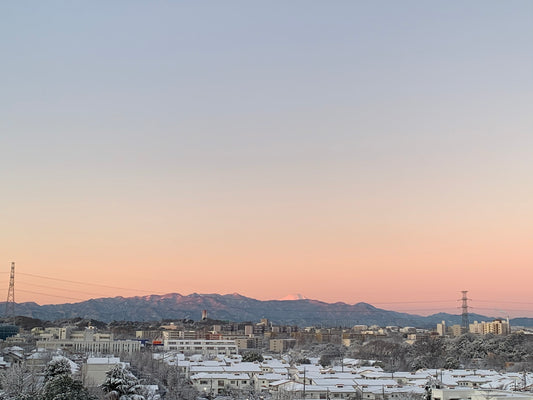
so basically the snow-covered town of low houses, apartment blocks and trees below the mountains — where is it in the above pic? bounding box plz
[0,311,533,400]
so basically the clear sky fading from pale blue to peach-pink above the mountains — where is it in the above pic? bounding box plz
[0,0,533,317]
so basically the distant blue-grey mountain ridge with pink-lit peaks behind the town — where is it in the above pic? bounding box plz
[0,293,533,328]
